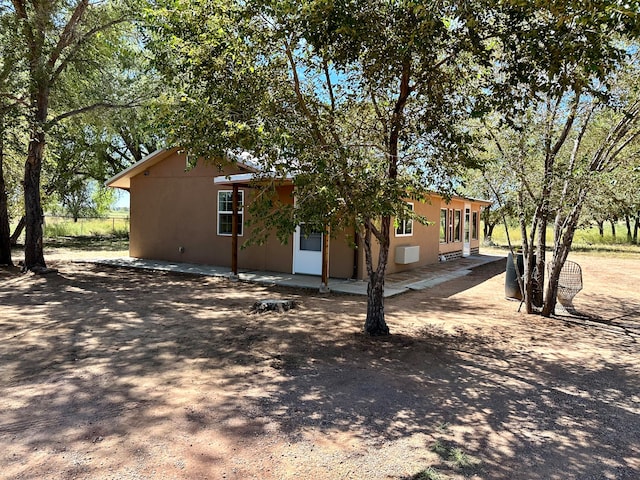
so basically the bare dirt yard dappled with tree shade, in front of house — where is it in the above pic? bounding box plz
[0,255,640,480]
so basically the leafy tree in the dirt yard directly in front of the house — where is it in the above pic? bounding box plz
[150,1,492,335]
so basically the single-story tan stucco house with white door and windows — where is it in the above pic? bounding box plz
[106,148,490,279]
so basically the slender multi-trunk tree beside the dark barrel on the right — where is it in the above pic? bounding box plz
[484,1,638,316]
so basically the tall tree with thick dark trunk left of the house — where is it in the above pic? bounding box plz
[7,0,140,271]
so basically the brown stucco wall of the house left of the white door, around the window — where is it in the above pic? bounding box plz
[130,152,292,272]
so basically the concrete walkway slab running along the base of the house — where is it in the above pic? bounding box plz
[89,255,504,297]
